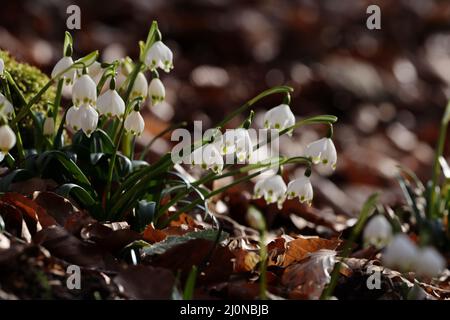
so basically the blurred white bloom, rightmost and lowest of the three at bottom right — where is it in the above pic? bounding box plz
[413,247,446,278]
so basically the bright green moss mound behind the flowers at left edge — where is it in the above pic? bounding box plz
[0,50,55,118]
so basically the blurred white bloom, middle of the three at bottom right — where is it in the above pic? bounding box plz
[382,233,417,271]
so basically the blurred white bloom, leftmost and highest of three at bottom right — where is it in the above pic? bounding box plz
[363,214,392,248]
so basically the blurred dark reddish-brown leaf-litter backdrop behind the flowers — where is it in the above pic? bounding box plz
[0,0,450,219]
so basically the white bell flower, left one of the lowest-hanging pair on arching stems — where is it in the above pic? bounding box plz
[254,175,287,209]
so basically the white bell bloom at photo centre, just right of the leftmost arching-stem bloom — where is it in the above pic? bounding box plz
[214,128,253,162]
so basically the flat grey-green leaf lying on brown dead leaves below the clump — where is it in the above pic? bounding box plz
[142,229,228,256]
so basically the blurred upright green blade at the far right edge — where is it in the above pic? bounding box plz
[427,102,450,218]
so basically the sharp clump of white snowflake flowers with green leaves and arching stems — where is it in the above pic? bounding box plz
[0,22,337,260]
